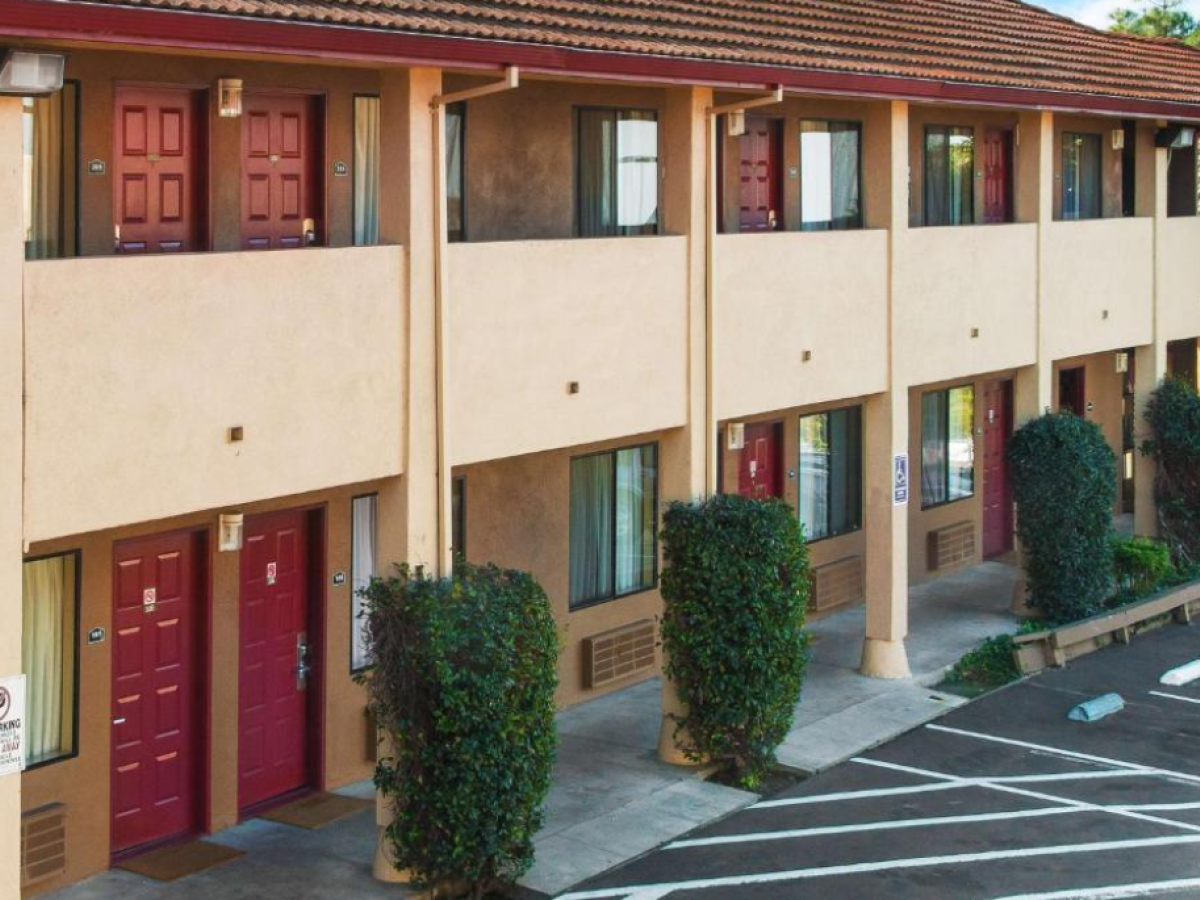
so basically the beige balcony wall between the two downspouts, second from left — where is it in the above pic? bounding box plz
[449,238,688,464]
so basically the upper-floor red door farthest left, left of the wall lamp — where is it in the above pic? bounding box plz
[113,88,208,253]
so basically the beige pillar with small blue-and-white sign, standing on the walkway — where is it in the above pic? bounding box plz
[860,101,913,678]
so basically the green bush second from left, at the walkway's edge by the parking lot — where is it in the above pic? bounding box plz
[662,496,809,787]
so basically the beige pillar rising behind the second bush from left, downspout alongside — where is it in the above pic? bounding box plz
[659,88,716,766]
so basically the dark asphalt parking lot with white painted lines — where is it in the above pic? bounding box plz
[560,625,1200,900]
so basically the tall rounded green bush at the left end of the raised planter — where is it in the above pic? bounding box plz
[1008,413,1116,622]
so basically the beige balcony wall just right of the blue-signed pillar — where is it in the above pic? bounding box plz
[894,224,1037,385]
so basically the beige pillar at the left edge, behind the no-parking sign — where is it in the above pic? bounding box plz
[0,97,25,898]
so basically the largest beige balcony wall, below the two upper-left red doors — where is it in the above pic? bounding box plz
[25,247,404,541]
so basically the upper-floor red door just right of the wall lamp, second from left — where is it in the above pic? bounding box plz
[241,94,325,250]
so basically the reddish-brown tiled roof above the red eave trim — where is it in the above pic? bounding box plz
[65,0,1200,103]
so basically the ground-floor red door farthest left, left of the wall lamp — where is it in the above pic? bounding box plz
[112,534,203,856]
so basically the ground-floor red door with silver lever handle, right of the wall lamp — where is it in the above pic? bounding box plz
[238,510,312,810]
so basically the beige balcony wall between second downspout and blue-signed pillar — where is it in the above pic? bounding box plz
[716,232,888,419]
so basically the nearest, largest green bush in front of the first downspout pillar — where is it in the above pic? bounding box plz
[362,562,558,898]
